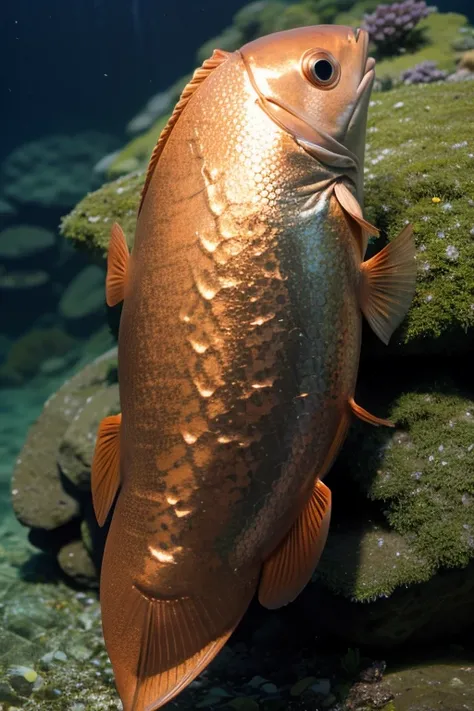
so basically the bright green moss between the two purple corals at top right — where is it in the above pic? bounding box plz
[377,12,468,79]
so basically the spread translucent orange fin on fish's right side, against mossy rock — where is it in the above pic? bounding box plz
[360,225,416,344]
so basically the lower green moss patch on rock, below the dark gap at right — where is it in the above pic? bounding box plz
[352,382,474,568]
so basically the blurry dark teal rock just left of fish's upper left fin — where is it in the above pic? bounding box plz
[59,264,105,333]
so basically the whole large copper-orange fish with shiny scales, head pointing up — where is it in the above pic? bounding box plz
[92,26,415,711]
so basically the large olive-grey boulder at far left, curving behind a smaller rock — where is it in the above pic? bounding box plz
[12,350,116,531]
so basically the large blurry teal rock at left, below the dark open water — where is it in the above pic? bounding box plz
[0,131,117,209]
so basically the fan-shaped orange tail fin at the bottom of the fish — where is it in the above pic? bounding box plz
[110,574,257,711]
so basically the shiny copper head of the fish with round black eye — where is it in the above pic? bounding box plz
[240,25,375,185]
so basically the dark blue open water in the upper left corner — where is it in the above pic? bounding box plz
[0,0,245,163]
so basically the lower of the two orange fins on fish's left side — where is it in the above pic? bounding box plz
[91,414,122,526]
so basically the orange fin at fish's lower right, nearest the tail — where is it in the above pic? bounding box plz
[258,479,331,610]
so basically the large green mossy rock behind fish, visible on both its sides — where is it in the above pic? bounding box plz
[61,80,474,357]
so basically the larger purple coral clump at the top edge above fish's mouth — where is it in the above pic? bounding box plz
[363,0,436,55]
